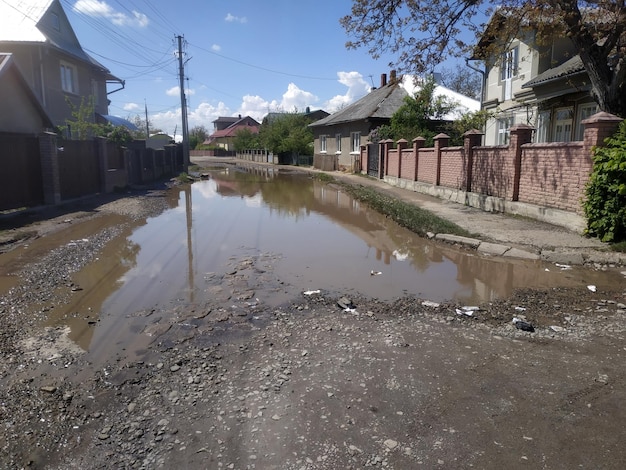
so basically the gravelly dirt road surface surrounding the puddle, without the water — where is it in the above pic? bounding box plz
[0,174,626,469]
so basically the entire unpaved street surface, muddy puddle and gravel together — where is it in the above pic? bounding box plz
[0,166,626,470]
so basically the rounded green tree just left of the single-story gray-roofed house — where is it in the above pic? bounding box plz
[259,112,313,162]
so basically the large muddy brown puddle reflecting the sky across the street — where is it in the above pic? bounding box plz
[3,167,611,353]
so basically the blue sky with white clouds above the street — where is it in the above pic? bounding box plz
[61,0,454,135]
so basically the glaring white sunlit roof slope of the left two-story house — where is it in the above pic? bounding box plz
[0,0,53,42]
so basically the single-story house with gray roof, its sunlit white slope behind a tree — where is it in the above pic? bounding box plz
[309,70,480,171]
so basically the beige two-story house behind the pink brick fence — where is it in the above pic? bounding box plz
[472,12,598,145]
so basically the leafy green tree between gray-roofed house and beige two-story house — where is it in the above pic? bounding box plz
[378,77,458,146]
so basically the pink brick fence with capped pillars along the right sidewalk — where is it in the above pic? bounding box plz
[361,112,622,228]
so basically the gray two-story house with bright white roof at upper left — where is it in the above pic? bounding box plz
[0,0,124,134]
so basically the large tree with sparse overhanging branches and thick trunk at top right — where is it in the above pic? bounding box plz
[340,0,626,117]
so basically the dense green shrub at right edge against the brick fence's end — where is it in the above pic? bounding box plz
[583,121,626,243]
